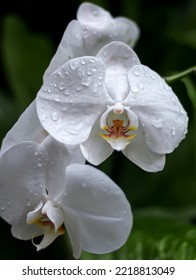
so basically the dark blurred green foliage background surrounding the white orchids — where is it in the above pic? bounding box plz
[0,0,196,259]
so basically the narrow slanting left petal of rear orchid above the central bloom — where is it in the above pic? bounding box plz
[43,20,84,81]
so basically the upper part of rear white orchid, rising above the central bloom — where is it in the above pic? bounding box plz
[44,3,140,80]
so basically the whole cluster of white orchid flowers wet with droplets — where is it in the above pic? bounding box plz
[0,3,188,258]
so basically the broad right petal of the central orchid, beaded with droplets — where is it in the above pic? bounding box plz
[123,65,188,154]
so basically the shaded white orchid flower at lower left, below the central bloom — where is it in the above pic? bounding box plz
[0,136,132,258]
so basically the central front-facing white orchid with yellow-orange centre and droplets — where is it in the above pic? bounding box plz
[36,42,188,172]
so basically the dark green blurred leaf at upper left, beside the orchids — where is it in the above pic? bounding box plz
[2,15,52,107]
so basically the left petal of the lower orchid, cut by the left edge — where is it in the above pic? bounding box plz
[0,142,46,223]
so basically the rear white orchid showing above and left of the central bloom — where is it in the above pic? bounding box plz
[0,3,139,155]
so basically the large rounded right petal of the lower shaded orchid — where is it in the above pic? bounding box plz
[61,164,132,254]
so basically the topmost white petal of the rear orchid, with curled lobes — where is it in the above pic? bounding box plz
[77,3,139,55]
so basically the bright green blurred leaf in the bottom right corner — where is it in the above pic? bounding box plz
[117,209,196,260]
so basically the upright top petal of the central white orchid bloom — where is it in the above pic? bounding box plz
[97,42,140,102]
